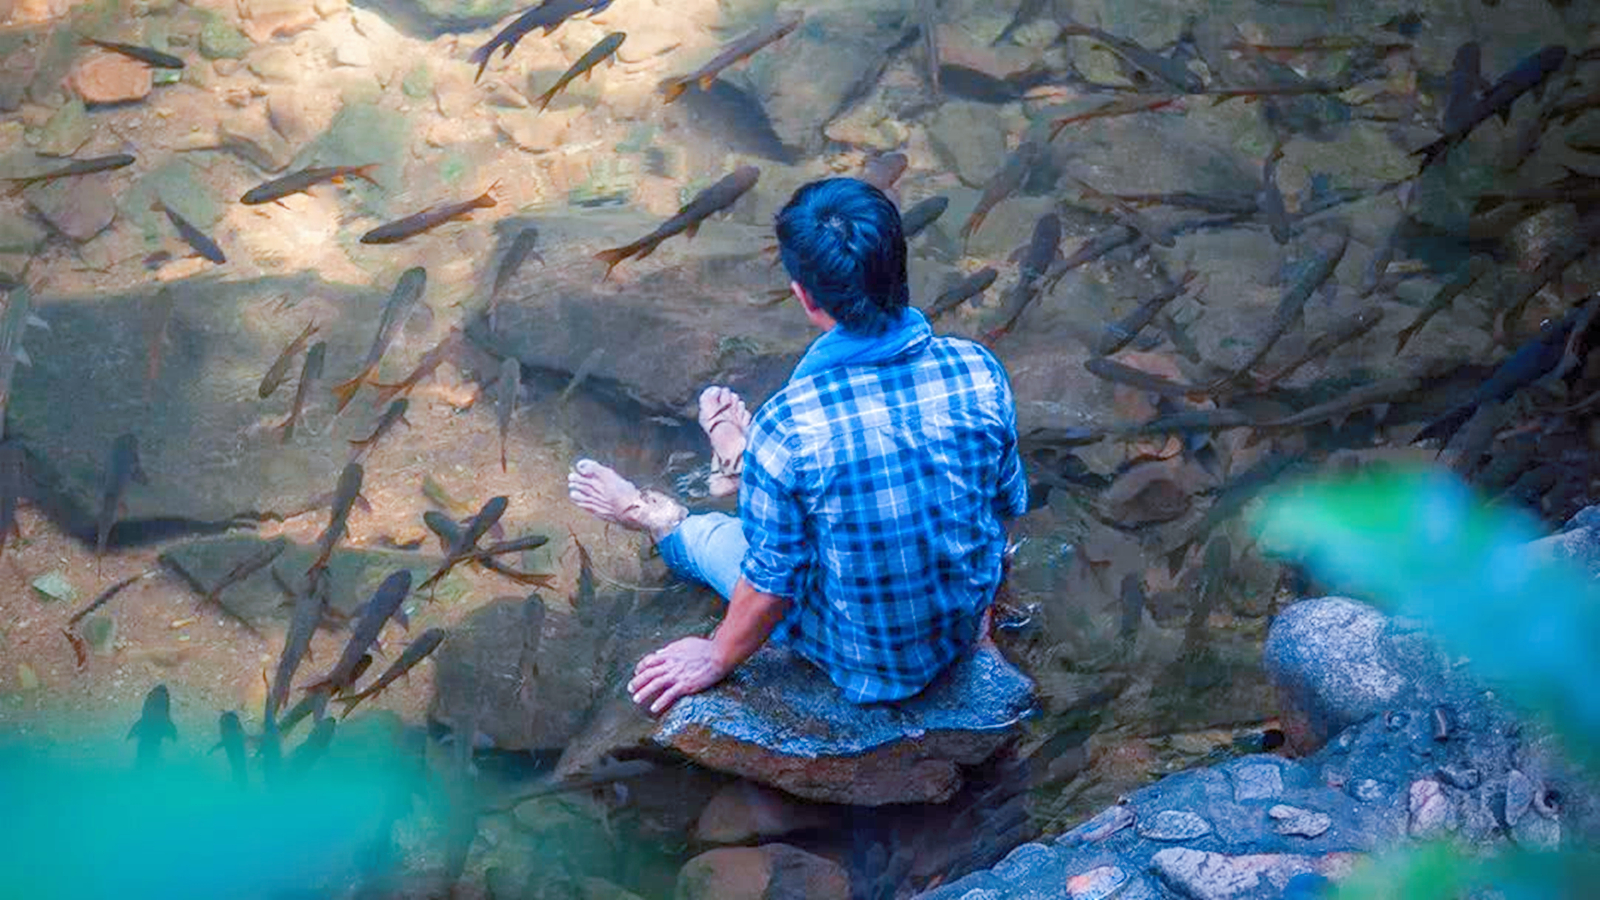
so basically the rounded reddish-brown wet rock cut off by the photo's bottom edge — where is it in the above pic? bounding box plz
[674,844,850,900]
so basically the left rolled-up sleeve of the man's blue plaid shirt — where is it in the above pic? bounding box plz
[739,418,813,599]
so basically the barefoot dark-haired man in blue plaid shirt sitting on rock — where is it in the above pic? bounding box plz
[568,178,1027,713]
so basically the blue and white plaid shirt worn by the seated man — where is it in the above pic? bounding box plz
[739,315,1027,703]
